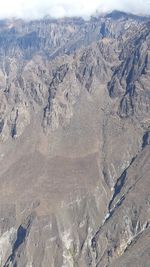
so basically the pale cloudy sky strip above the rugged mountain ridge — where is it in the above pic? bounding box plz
[0,0,150,19]
